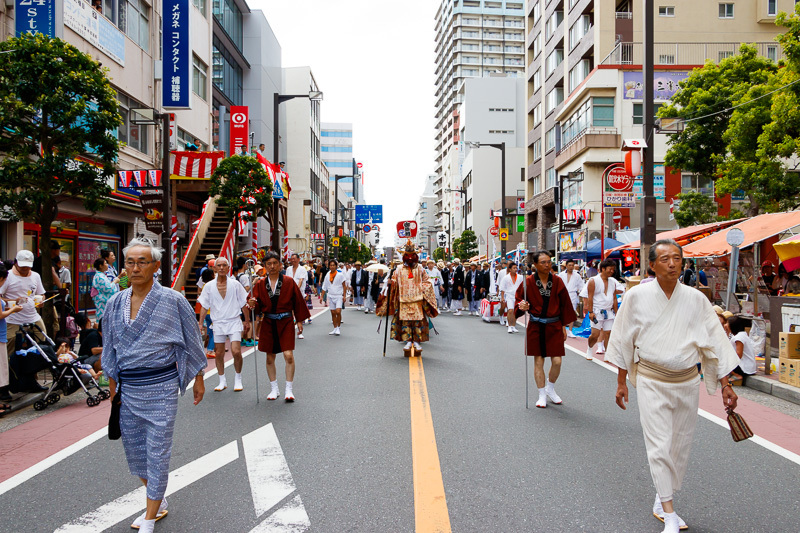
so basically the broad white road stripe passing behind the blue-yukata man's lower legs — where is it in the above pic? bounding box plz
[55,441,239,533]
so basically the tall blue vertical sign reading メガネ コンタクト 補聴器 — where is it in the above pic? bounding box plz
[162,0,192,109]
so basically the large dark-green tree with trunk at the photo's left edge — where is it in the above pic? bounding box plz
[0,34,122,300]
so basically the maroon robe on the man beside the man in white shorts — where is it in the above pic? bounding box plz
[253,276,311,353]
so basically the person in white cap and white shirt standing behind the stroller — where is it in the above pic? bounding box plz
[0,250,45,391]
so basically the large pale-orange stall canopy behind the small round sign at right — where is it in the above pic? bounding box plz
[683,211,800,257]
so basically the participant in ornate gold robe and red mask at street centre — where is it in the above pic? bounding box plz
[386,239,439,357]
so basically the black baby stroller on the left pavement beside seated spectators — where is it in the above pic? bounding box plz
[16,324,111,411]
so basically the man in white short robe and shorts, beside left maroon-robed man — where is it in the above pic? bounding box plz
[197,257,250,392]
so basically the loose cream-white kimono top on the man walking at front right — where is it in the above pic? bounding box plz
[605,282,739,394]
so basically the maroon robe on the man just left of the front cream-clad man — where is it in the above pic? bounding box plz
[514,272,578,357]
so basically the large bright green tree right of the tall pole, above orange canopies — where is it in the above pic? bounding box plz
[658,44,780,215]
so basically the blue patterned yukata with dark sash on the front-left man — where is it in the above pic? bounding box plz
[101,283,206,500]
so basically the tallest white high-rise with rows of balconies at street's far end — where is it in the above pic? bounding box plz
[434,0,525,238]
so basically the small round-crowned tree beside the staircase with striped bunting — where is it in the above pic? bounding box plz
[208,155,272,245]
